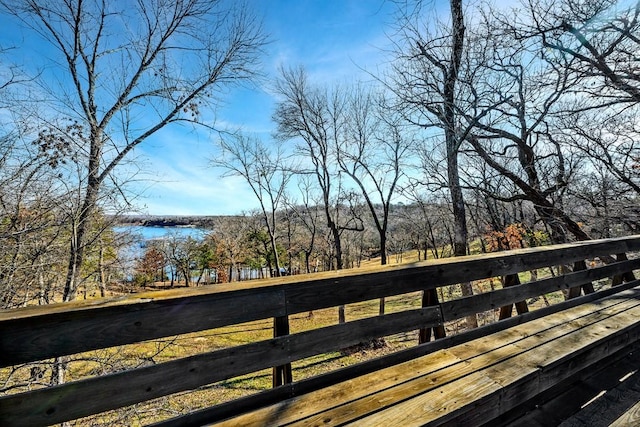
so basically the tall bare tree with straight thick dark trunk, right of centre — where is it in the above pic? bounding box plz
[390,0,477,327]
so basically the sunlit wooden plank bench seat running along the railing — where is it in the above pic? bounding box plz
[206,288,640,426]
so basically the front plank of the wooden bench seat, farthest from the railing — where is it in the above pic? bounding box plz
[350,298,640,426]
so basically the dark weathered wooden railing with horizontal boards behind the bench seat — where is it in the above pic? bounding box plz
[0,236,640,426]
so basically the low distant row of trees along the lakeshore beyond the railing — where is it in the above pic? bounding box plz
[130,201,476,289]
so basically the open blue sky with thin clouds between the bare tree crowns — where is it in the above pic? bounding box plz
[138,0,394,215]
